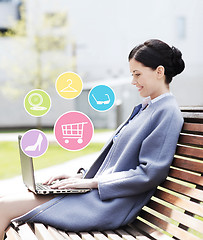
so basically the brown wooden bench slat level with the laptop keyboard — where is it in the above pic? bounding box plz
[161,180,203,201]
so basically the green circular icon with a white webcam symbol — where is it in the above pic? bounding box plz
[24,89,51,117]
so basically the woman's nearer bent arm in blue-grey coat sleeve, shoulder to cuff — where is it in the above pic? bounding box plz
[98,107,183,200]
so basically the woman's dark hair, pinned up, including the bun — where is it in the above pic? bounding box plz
[128,39,185,84]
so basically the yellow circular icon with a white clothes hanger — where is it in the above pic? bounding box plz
[56,72,83,99]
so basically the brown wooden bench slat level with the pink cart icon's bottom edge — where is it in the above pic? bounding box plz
[176,145,203,159]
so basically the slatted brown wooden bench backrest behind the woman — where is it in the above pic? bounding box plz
[130,108,203,240]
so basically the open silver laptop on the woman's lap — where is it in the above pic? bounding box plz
[18,135,91,195]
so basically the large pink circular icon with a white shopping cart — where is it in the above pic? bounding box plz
[54,111,94,151]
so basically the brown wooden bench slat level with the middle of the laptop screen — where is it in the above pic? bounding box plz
[172,157,203,173]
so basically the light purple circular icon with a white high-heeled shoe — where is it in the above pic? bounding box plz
[20,129,48,157]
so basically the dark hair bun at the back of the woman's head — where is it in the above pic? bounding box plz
[171,46,185,77]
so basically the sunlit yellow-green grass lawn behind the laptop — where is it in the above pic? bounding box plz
[0,142,104,180]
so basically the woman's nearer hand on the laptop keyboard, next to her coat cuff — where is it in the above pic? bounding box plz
[51,177,98,189]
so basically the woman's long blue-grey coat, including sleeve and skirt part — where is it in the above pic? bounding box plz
[15,96,183,231]
